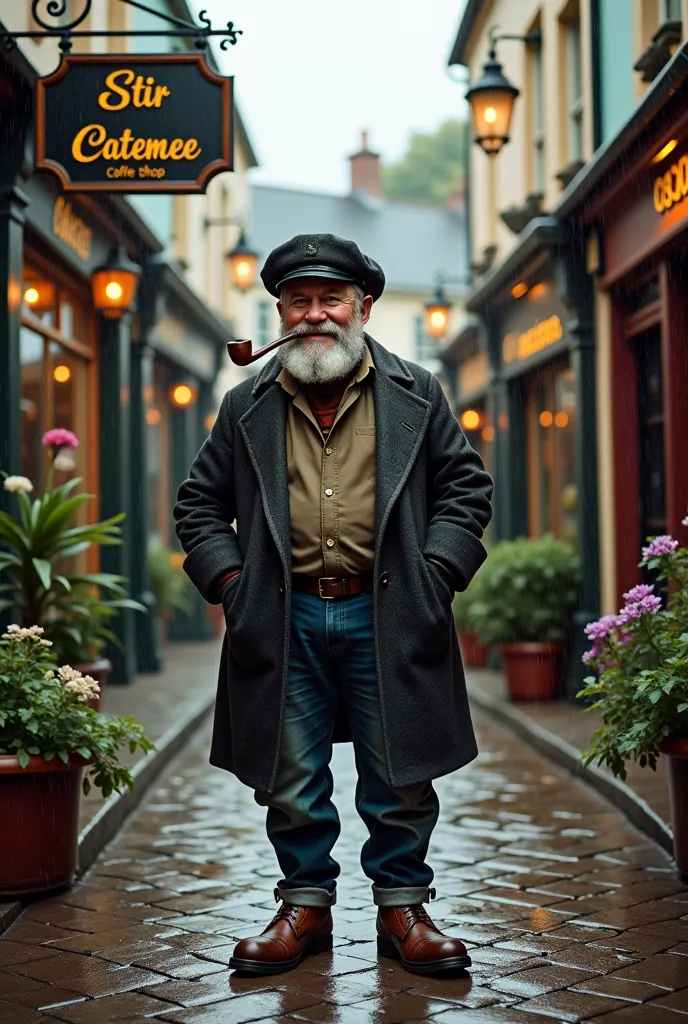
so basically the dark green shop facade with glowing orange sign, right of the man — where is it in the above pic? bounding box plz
[458,217,599,693]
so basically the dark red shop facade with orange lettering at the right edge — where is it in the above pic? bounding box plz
[560,47,688,611]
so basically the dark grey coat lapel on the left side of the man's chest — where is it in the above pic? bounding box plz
[239,384,292,577]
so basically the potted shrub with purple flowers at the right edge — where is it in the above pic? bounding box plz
[578,532,688,878]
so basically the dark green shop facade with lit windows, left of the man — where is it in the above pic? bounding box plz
[0,51,231,682]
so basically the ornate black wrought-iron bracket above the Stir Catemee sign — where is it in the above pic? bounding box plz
[0,0,243,53]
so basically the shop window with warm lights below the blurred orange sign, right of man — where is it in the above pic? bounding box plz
[526,365,578,544]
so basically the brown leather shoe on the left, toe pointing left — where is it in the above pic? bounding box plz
[229,903,332,974]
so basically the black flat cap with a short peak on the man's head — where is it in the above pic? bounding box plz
[260,234,385,300]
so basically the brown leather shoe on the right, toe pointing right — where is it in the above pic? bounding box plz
[378,906,471,974]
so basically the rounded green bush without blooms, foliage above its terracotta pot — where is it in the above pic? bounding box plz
[466,534,581,645]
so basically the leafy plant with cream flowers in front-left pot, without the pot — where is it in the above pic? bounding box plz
[0,625,155,797]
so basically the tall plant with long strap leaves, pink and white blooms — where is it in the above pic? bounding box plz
[0,429,146,679]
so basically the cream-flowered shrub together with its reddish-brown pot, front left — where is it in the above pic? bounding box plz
[0,625,154,895]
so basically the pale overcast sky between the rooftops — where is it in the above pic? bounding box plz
[192,0,466,191]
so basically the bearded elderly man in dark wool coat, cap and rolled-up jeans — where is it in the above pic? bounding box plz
[174,234,491,974]
